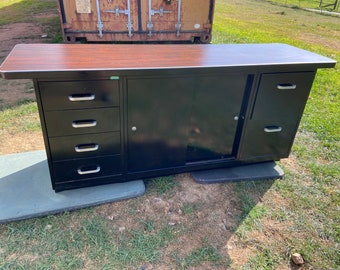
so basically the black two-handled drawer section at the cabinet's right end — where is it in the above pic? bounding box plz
[238,72,315,161]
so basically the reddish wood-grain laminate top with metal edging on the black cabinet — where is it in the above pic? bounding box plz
[0,44,336,79]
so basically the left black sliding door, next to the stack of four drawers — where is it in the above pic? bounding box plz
[127,77,193,172]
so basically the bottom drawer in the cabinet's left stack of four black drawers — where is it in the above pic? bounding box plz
[53,155,122,182]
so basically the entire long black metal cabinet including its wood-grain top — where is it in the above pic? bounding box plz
[0,44,335,191]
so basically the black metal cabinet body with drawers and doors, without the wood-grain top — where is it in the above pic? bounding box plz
[33,70,315,191]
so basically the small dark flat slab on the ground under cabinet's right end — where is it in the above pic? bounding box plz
[191,161,284,184]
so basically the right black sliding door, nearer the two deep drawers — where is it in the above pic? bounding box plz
[187,74,248,162]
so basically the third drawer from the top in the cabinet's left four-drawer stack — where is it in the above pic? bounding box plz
[49,132,121,161]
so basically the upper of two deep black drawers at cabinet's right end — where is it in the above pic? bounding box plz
[251,72,315,122]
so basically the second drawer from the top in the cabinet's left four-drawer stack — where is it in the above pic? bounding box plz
[45,108,120,137]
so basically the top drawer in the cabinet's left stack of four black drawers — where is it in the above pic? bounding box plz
[39,80,119,111]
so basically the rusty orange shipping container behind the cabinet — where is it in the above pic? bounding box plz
[58,0,215,43]
